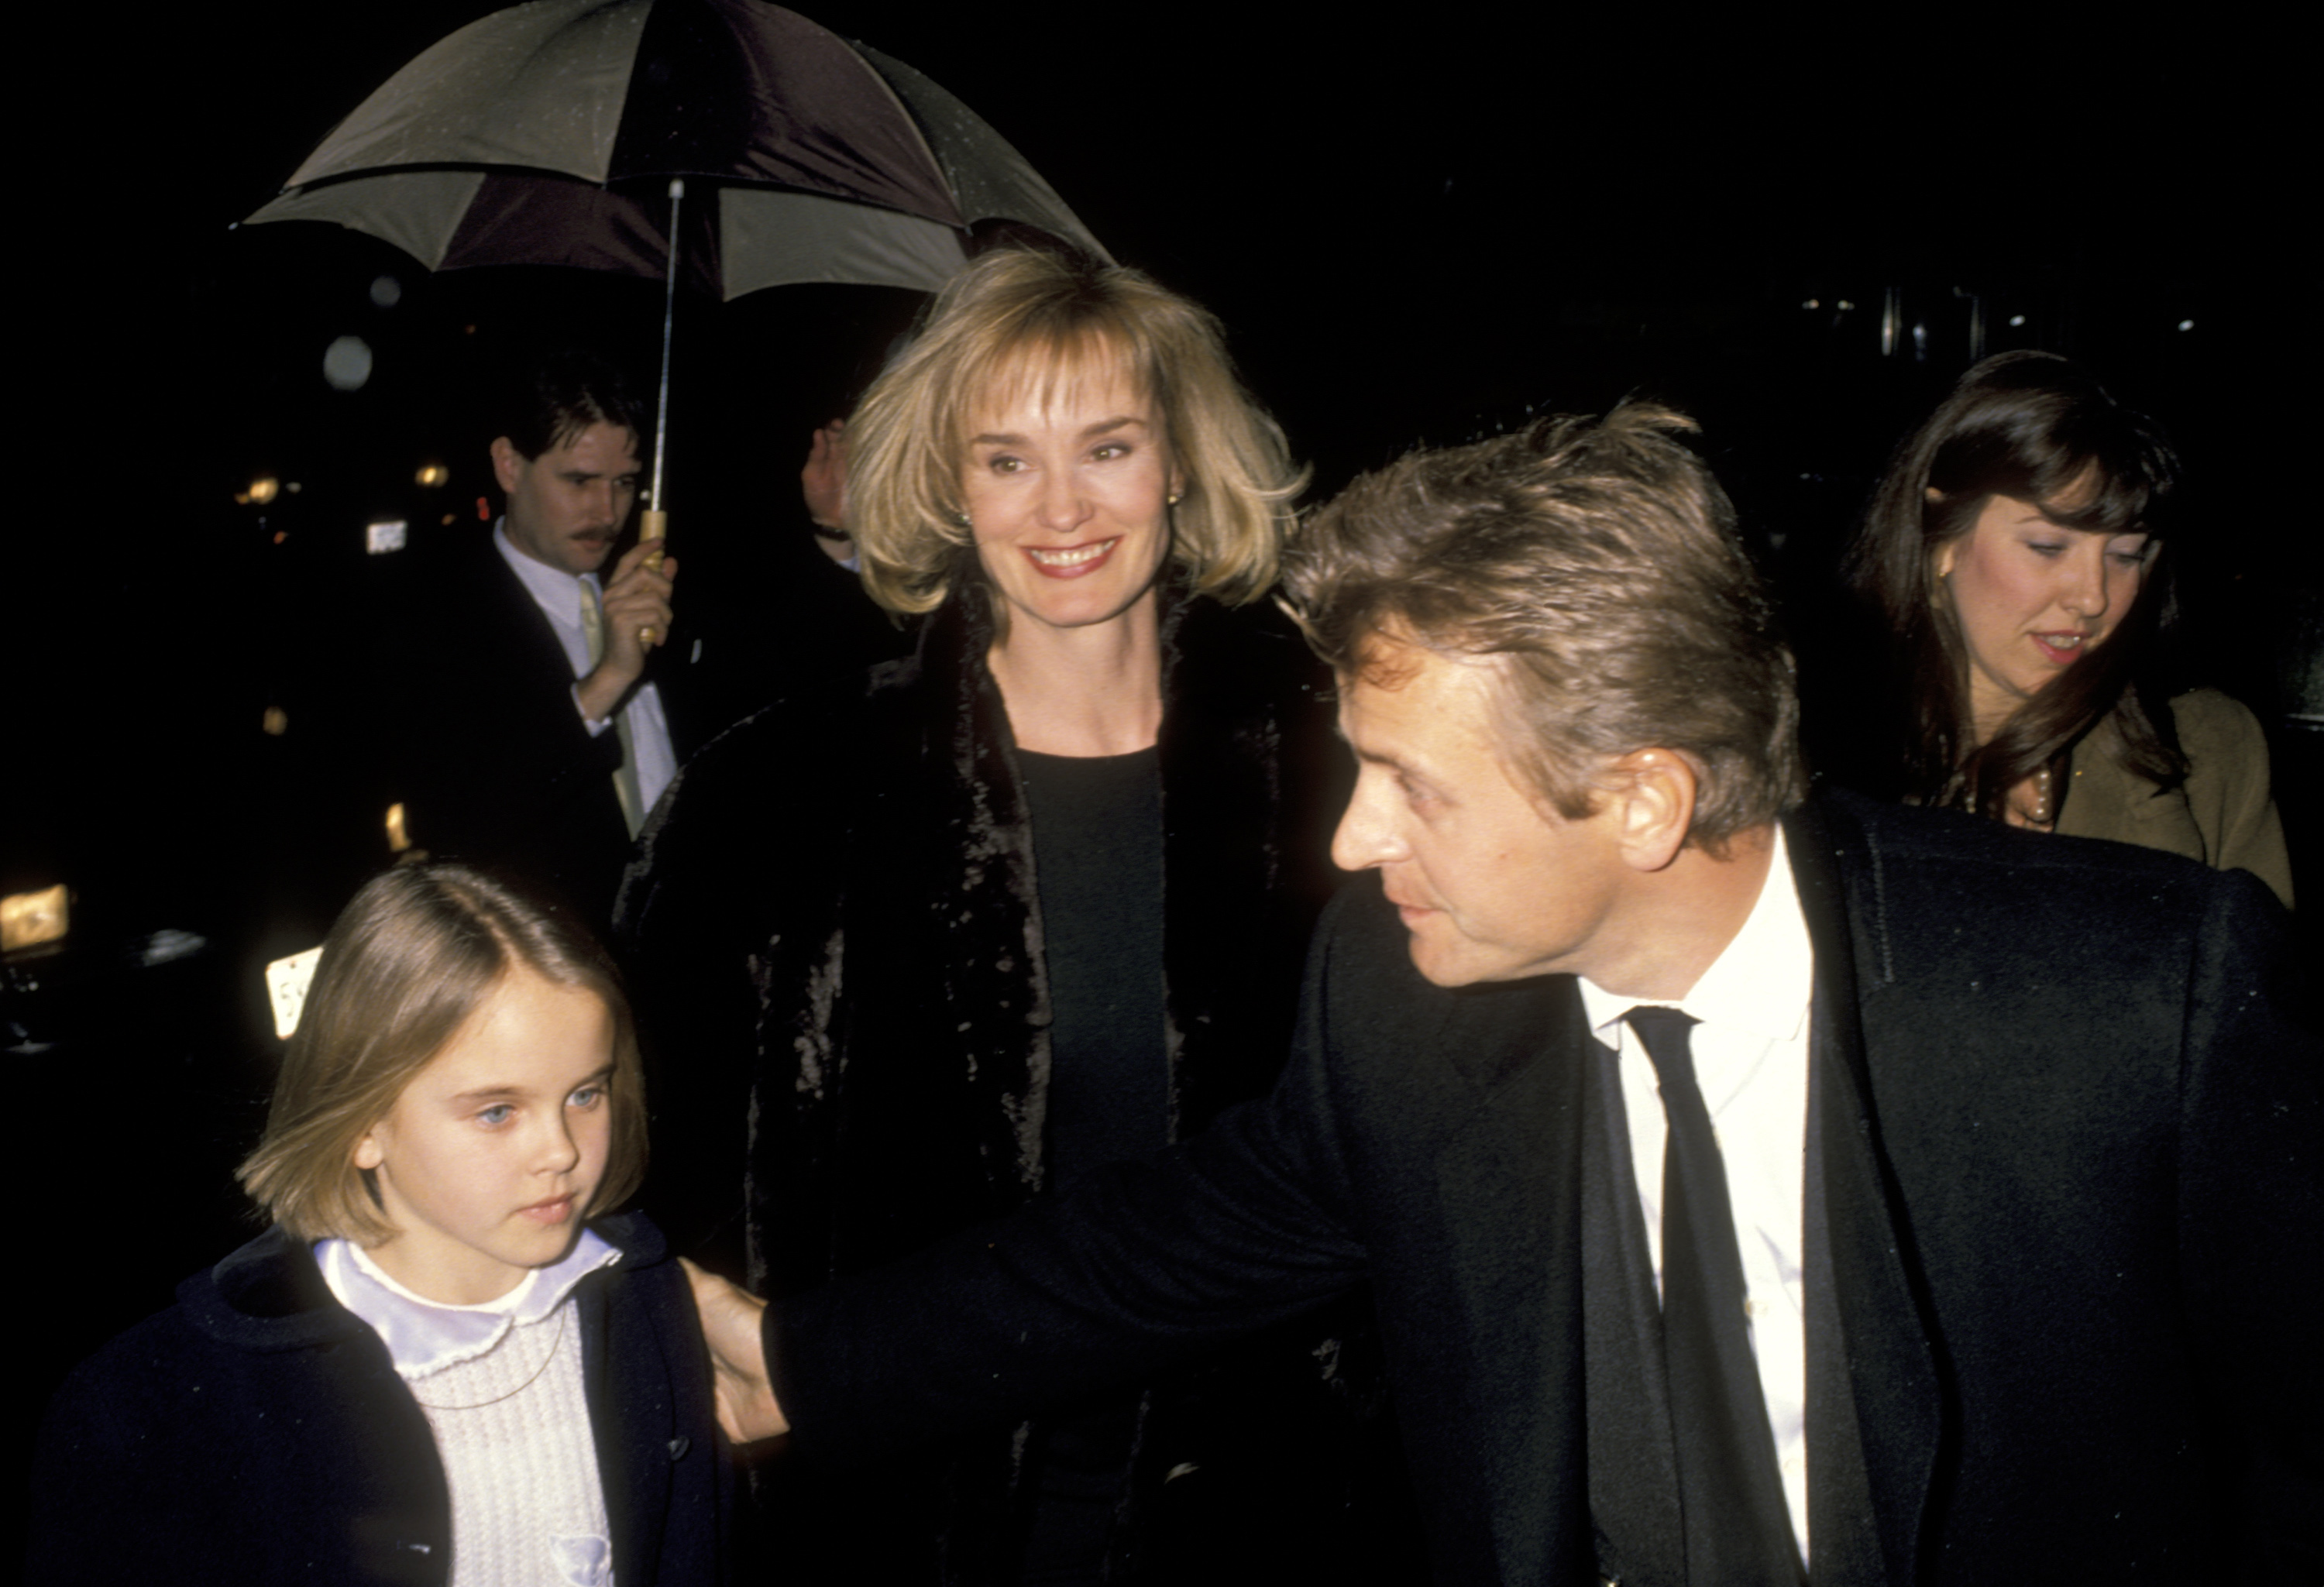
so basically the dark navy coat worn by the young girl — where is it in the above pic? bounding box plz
[30,1218,734,1587]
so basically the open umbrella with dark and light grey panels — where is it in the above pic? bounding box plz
[249,0,1109,532]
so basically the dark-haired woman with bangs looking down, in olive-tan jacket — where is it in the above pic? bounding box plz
[1850,351,2291,904]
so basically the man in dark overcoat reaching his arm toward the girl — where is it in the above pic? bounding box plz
[679,404,2324,1587]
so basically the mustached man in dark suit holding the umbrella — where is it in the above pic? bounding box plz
[395,353,700,932]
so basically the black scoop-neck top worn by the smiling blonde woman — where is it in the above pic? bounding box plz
[1018,748,1169,1190]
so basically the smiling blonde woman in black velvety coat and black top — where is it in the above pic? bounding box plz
[623,251,1376,1582]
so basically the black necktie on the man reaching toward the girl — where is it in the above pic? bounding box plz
[1624,1006,1799,1585]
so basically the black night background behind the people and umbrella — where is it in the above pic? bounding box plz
[13,0,2324,1506]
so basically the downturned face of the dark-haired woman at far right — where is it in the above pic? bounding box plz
[1934,495,2150,744]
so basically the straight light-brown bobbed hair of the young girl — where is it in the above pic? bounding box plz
[239,864,646,1245]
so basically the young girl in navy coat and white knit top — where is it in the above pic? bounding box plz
[33,864,732,1587]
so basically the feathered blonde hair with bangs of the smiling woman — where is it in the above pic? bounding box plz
[848,249,1306,613]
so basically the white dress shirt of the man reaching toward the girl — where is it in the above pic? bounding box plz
[1578,832,1815,1559]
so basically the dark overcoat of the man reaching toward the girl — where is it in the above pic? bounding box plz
[767,802,2324,1587]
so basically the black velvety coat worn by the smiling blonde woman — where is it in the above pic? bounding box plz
[621,590,1385,1580]
